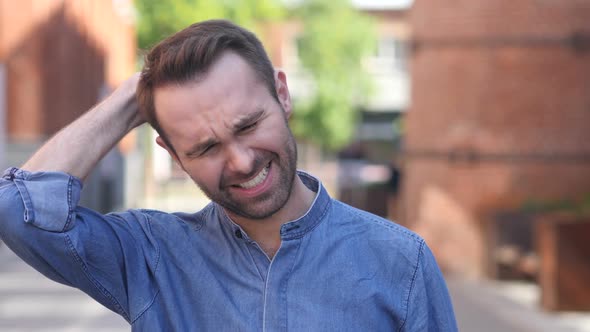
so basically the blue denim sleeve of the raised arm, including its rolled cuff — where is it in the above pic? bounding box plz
[0,168,159,323]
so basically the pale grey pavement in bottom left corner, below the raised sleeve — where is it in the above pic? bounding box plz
[0,245,130,332]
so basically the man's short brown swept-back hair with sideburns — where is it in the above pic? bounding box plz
[137,20,278,153]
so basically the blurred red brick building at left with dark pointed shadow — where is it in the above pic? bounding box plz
[0,0,135,141]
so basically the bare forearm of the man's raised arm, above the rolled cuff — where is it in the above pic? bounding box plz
[22,74,144,179]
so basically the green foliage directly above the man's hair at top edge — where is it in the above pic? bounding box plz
[135,0,285,49]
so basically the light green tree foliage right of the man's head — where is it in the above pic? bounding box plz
[292,0,376,149]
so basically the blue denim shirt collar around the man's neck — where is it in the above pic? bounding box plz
[215,171,331,240]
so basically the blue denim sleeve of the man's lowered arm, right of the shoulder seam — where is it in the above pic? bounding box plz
[403,242,458,332]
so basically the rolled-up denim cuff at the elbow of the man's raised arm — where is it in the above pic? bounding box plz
[2,168,82,232]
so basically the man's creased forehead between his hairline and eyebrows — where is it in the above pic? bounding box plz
[154,52,274,135]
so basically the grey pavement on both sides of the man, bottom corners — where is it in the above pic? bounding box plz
[0,241,590,332]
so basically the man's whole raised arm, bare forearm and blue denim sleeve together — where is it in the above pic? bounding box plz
[0,75,158,322]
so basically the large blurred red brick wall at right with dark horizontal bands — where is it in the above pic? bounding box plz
[403,0,590,275]
